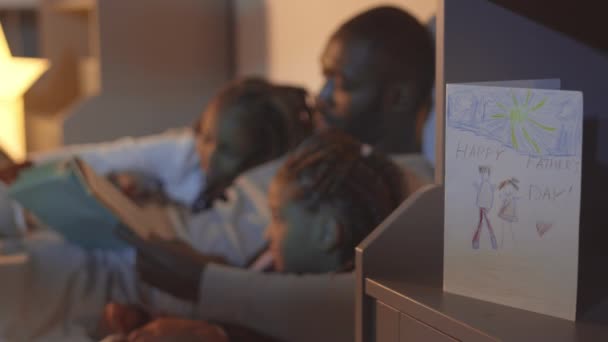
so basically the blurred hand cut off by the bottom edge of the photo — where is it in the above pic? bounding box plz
[127,318,229,342]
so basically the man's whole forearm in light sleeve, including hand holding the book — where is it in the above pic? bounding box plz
[128,232,355,341]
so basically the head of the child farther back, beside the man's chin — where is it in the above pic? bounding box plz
[195,78,312,206]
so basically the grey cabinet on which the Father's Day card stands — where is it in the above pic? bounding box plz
[356,0,608,342]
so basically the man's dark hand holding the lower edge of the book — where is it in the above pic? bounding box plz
[118,228,225,302]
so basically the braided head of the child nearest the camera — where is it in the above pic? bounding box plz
[268,130,406,273]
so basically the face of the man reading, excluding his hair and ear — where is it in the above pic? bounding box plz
[317,35,384,144]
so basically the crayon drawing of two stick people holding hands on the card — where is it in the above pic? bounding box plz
[472,166,519,249]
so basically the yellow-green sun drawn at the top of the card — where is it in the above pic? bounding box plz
[491,90,555,153]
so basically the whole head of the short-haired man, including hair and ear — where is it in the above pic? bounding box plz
[318,7,434,154]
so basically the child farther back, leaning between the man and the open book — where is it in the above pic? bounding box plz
[101,78,312,266]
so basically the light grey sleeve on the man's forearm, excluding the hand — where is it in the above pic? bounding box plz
[198,264,355,342]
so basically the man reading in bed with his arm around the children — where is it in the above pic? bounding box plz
[117,7,434,341]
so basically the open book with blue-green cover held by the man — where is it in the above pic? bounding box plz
[9,158,186,249]
